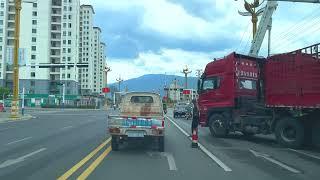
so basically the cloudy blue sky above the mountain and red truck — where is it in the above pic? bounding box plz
[80,0,320,83]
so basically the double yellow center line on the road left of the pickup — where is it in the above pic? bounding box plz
[58,137,111,180]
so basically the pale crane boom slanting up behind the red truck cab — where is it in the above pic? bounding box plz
[244,0,320,57]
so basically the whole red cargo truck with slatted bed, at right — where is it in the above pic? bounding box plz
[198,44,320,148]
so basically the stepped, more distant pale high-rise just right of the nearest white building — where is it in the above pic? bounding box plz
[79,5,105,95]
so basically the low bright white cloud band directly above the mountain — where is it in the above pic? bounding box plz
[108,49,232,83]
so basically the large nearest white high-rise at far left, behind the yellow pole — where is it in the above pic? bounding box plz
[0,0,80,95]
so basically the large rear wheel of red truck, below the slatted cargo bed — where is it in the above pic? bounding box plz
[275,117,305,148]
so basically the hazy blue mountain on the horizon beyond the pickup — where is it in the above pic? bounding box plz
[111,74,197,95]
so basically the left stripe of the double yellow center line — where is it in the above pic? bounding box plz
[57,137,111,180]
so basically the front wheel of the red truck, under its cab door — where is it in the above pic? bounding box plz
[209,114,228,137]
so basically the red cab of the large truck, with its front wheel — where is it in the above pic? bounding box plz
[198,53,265,136]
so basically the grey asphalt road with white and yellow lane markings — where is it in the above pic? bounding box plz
[0,107,320,180]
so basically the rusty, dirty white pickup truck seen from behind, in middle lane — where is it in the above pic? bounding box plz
[108,92,165,152]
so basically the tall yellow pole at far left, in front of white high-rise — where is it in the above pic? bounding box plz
[11,0,21,118]
